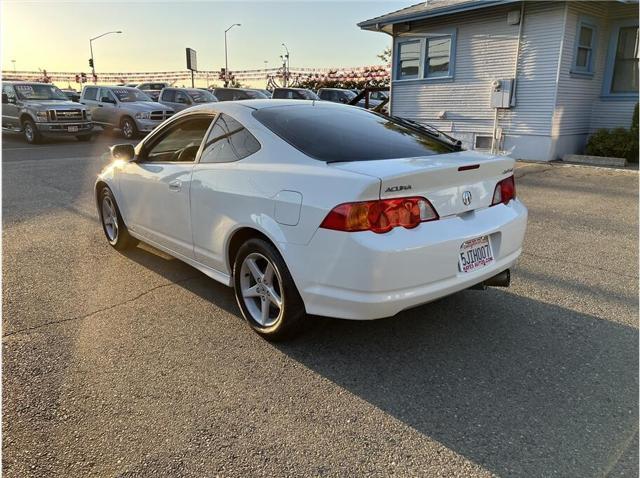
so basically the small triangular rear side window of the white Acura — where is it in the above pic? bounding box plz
[200,114,260,163]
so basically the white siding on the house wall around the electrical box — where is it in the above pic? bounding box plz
[391,2,564,157]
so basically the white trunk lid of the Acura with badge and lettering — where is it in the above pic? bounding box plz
[331,151,515,217]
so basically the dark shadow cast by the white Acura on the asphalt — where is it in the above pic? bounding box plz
[122,246,638,477]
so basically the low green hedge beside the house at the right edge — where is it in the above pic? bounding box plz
[585,104,638,163]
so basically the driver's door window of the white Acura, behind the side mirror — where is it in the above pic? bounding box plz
[143,116,213,163]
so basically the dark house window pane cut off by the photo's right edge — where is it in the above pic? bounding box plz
[611,27,638,93]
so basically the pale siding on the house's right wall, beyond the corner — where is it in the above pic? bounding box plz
[551,2,637,159]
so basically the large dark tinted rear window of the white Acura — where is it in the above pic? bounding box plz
[253,103,454,163]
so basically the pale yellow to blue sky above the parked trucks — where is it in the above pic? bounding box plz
[2,0,408,73]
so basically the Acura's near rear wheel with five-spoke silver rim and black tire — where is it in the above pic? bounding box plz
[233,239,306,341]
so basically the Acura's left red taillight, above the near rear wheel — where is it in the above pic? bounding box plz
[320,197,438,234]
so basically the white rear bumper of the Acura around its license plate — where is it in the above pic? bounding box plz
[282,200,527,320]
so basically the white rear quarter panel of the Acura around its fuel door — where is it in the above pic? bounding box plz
[191,115,380,273]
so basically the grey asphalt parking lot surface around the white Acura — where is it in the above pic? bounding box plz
[2,135,638,477]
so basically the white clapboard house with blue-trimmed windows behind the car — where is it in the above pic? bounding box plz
[358,0,638,161]
